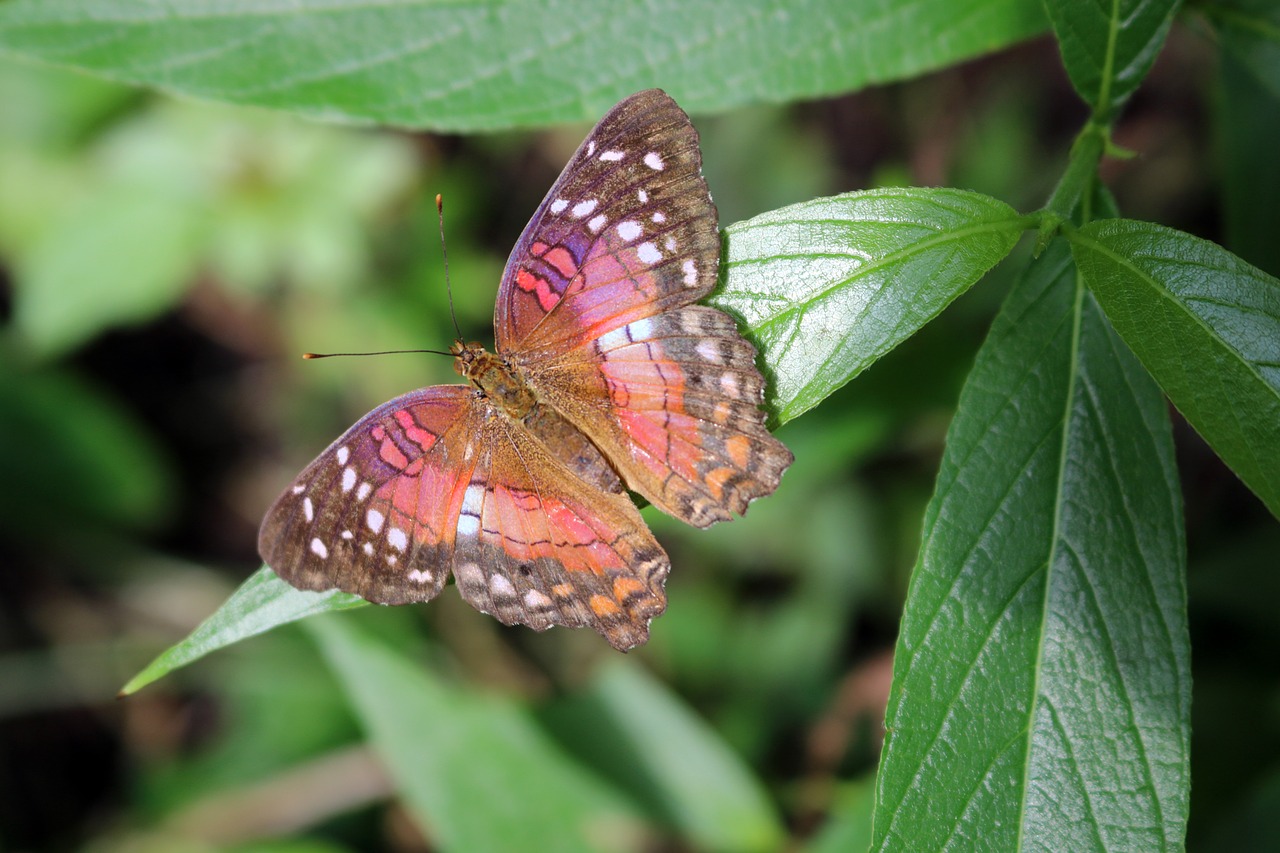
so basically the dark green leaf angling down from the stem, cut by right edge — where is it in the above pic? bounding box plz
[1071,219,1280,516]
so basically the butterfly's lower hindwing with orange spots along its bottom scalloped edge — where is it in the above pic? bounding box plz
[454,409,671,651]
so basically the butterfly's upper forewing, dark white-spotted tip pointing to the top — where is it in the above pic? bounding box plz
[494,90,719,353]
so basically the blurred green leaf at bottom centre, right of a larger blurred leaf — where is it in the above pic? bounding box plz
[552,661,785,852]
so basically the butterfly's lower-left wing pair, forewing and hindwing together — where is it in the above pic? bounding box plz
[259,386,671,651]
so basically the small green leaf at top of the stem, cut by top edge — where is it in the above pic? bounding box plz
[1044,0,1179,123]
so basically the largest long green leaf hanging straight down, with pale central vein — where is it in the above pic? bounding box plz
[874,241,1190,850]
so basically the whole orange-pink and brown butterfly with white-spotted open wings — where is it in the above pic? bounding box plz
[259,88,792,651]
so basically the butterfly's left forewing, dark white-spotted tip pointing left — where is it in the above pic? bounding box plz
[257,386,479,605]
